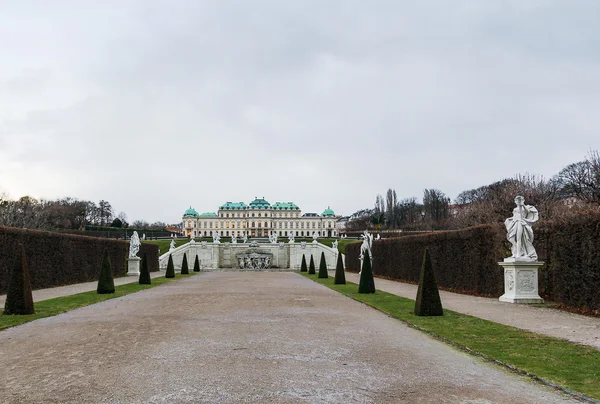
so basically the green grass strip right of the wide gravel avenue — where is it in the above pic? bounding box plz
[301,273,600,400]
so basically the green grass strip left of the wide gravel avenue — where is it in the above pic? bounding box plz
[0,273,198,330]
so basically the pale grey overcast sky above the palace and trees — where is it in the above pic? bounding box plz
[0,0,600,223]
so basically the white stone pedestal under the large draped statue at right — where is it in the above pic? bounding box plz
[498,258,544,303]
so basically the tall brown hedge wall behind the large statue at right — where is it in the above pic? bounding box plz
[346,210,600,313]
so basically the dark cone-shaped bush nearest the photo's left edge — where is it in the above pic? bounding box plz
[4,243,35,314]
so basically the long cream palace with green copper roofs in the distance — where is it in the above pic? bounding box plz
[182,198,340,237]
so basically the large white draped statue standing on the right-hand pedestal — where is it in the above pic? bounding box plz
[504,196,539,261]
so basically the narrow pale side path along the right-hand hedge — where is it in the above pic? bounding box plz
[338,272,600,349]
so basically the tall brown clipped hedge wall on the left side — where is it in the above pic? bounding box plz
[0,227,158,293]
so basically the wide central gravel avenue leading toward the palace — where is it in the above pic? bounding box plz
[0,272,576,403]
